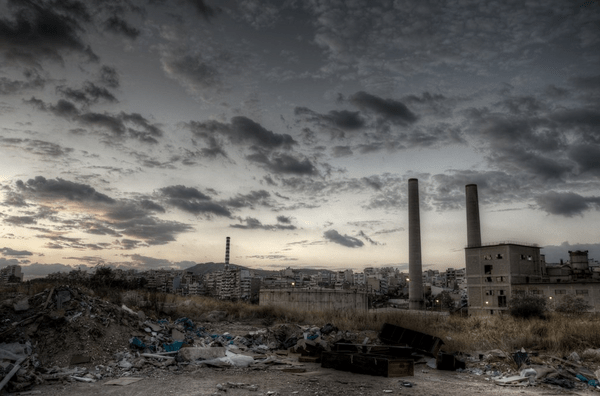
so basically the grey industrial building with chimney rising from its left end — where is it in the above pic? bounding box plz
[465,184,600,315]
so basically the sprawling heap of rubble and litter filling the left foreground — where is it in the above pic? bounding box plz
[0,286,375,392]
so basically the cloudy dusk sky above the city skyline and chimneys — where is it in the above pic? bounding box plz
[0,0,600,276]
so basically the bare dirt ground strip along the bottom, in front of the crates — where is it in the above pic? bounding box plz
[30,363,593,396]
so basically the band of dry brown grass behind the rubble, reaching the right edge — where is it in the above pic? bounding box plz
[1,283,600,356]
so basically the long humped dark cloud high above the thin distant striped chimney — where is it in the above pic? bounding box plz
[187,116,297,150]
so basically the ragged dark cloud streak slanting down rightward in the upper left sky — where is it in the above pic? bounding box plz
[23,96,163,144]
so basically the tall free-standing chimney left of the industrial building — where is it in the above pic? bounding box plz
[408,179,424,310]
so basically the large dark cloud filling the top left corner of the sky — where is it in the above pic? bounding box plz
[0,0,98,67]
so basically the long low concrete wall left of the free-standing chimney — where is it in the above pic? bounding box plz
[259,289,368,311]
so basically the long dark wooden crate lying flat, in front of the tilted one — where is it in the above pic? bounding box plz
[321,352,415,377]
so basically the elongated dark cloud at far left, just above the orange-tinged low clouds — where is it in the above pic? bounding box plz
[16,176,115,204]
